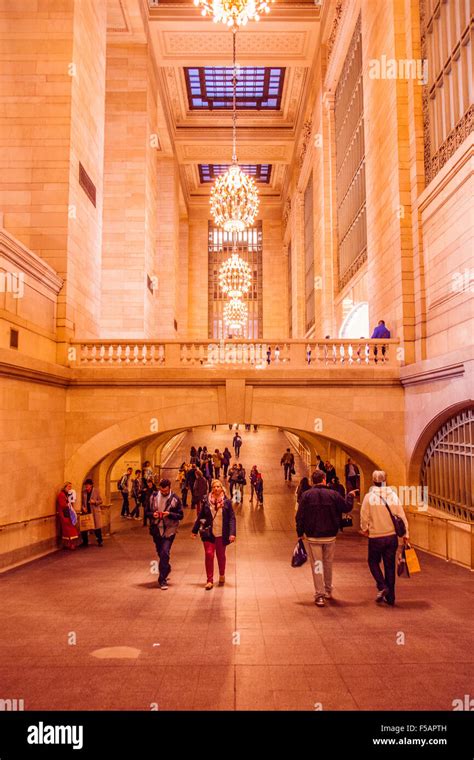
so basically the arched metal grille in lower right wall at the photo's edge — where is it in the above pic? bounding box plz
[421,408,474,522]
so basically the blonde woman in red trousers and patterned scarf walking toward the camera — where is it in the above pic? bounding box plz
[192,479,236,591]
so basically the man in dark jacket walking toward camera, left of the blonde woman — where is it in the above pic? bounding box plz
[148,478,184,591]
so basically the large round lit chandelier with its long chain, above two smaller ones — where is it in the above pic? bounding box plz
[210,28,259,233]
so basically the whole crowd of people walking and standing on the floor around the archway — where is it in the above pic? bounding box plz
[57,430,408,607]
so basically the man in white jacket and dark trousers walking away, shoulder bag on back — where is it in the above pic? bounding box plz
[360,470,408,606]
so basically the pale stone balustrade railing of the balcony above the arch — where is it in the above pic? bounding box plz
[68,339,403,370]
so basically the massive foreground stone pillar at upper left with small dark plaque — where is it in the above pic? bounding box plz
[0,0,107,344]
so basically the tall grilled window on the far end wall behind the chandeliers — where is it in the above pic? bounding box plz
[209,222,263,340]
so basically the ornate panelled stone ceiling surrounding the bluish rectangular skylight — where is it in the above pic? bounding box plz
[108,0,321,202]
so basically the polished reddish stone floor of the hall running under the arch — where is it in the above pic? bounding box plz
[0,427,474,710]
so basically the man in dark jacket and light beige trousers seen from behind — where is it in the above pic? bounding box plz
[296,469,355,607]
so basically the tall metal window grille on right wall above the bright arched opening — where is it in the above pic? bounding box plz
[334,16,367,289]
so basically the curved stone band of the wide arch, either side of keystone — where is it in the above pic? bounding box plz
[65,400,406,483]
